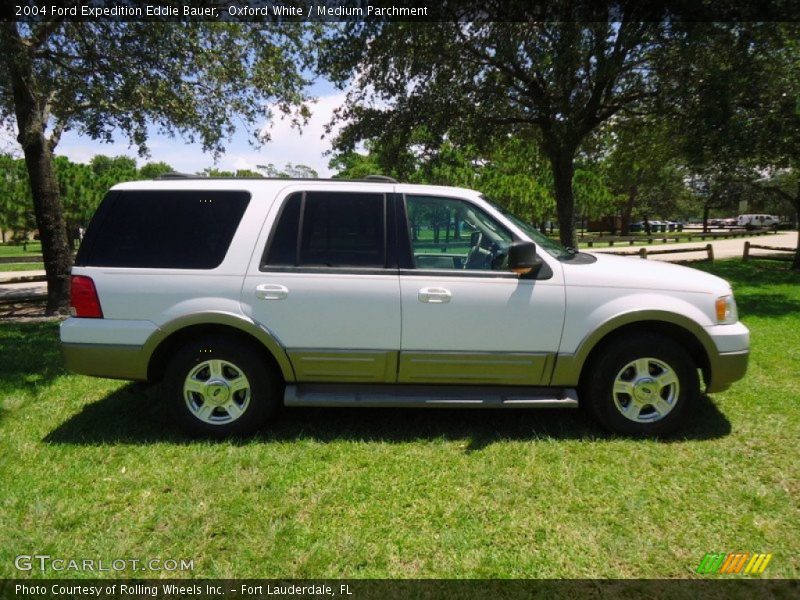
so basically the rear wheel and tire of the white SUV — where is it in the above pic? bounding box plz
[164,336,283,439]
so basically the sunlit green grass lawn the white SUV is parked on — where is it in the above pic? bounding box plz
[0,261,800,578]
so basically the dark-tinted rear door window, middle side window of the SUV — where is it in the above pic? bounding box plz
[264,192,386,268]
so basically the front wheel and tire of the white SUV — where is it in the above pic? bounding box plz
[581,333,700,437]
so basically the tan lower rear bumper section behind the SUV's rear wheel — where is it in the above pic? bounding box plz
[61,342,147,381]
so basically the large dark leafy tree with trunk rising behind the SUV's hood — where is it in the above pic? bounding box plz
[320,13,665,246]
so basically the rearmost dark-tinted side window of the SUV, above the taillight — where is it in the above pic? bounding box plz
[75,191,250,269]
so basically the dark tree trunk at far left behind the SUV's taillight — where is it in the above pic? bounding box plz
[2,23,72,315]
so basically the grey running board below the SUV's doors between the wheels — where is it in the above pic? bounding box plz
[283,383,578,408]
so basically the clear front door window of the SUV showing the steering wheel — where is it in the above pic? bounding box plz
[406,196,513,271]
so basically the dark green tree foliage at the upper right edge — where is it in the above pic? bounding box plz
[663,22,800,270]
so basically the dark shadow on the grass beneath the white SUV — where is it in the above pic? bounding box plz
[44,384,731,452]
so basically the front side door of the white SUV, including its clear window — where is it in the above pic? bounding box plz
[398,195,565,385]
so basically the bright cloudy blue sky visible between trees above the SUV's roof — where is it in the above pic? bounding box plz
[2,80,345,177]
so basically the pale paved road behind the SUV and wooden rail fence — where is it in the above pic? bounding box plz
[0,231,797,302]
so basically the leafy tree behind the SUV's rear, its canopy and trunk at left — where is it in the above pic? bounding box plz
[0,20,316,313]
